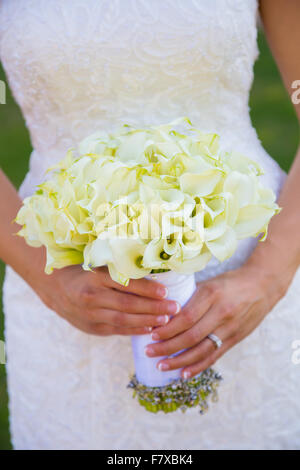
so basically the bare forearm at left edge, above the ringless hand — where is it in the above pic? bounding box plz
[0,171,46,286]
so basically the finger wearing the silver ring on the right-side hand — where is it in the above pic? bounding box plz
[157,327,230,371]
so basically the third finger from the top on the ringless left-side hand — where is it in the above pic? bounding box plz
[89,308,170,332]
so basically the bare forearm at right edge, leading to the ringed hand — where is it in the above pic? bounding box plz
[246,150,300,288]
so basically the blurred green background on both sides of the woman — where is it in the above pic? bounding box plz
[0,32,299,450]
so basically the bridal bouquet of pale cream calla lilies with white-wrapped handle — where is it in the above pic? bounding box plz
[16,118,279,412]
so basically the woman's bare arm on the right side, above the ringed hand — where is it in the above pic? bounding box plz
[249,0,300,287]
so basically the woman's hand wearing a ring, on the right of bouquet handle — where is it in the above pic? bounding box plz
[145,267,288,379]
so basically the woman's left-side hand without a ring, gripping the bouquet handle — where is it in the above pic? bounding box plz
[33,266,178,336]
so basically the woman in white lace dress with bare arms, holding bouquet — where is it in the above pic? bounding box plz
[0,0,300,449]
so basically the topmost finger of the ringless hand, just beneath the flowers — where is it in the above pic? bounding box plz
[98,268,168,299]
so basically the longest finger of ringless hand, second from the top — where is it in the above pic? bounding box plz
[94,289,180,315]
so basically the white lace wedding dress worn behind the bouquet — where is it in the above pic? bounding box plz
[0,0,300,449]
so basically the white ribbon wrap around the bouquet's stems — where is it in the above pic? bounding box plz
[132,271,196,387]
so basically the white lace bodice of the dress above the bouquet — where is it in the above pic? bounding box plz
[0,0,264,182]
